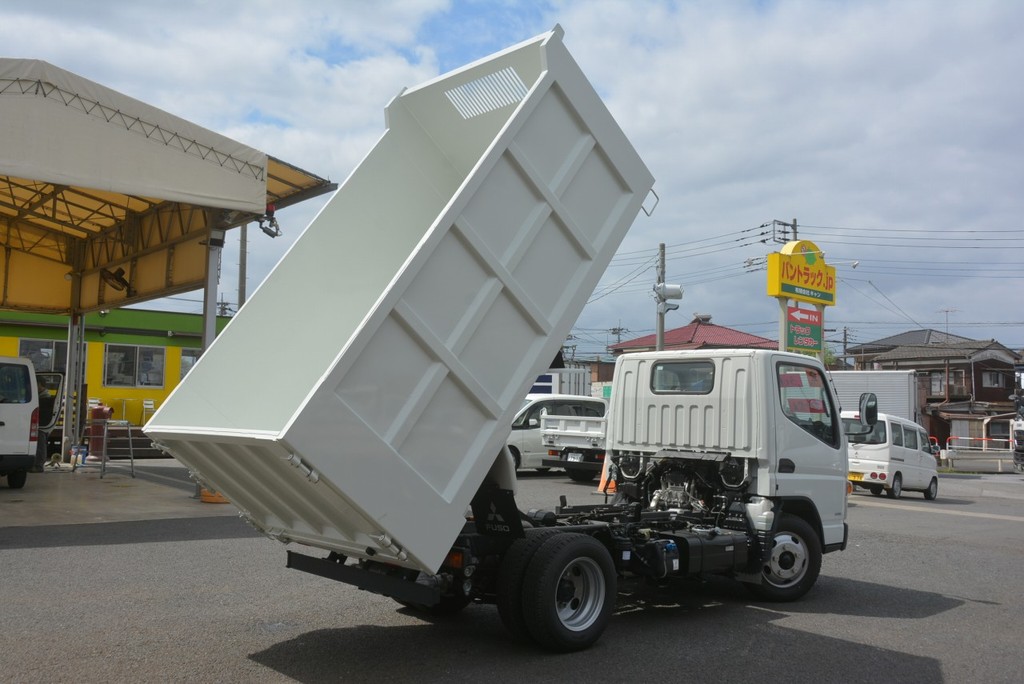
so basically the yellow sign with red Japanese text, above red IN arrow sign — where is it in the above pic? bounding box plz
[768,240,836,306]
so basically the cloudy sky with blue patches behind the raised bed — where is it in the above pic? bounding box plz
[0,0,1024,356]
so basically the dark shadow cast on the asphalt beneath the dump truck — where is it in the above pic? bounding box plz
[250,580,942,684]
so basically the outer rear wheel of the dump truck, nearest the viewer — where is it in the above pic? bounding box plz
[522,532,616,652]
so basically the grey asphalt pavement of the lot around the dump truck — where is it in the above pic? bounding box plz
[0,460,1024,684]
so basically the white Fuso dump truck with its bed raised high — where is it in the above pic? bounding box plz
[145,27,868,651]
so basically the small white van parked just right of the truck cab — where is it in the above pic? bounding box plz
[842,411,939,500]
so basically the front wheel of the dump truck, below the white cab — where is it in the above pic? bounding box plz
[749,514,821,602]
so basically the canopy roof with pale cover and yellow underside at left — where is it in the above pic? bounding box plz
[0,58,336,313]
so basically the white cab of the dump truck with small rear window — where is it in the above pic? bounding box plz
[607,349,847,552]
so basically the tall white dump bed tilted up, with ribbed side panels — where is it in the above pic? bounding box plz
[145,27,653,572]
